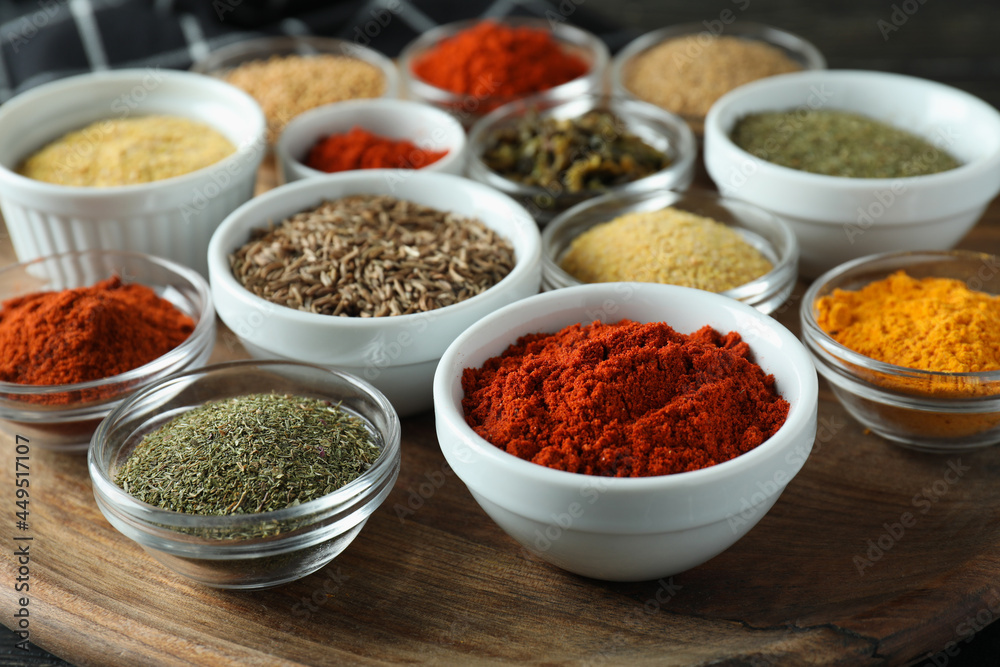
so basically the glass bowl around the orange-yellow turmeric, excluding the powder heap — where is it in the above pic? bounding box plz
[800,250,1000,452]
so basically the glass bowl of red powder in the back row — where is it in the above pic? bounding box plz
[399,17,610,127]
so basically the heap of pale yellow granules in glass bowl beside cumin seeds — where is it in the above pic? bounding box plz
[560,207,773,292]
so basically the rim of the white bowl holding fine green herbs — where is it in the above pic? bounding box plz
[705,69,1000,190]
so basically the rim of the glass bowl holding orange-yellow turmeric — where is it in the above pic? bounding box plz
[799,248,1000,380]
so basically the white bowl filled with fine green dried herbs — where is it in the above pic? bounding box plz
[705,70,1000,277]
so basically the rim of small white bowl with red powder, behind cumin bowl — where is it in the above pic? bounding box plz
[274,97,467,176]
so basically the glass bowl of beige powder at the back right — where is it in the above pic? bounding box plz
[611,21,826,137]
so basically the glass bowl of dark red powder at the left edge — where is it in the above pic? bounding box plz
[0,250,216,452]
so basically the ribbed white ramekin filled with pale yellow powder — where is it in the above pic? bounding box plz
[0,68,265,275]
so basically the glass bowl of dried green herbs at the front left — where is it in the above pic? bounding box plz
[88,361,400,589]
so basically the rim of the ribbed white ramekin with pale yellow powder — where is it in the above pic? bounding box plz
[0,68,267,199]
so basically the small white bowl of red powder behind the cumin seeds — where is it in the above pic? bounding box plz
[274,98,466,183]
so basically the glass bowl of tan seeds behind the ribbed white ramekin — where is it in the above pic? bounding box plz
[191,35,399,144]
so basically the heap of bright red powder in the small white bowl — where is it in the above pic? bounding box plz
[305,127,448,173]
